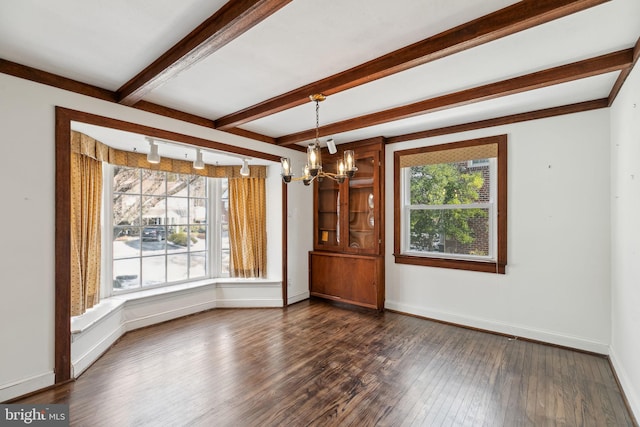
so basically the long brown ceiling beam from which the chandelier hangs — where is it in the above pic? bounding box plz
[215,0,610,130]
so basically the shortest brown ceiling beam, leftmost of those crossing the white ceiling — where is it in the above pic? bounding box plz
[117,0,291,106]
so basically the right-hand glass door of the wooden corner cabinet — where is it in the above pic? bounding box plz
[347,152,379,253]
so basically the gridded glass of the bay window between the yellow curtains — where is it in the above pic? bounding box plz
[110,166,215,291]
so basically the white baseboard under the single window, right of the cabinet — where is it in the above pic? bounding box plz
[384,300,609,355]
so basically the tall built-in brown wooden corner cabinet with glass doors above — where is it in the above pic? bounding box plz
[309,138,384,310]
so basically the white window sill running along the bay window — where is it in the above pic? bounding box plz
[71,277,281,335]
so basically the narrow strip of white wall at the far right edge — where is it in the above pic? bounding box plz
[610,65,640,419]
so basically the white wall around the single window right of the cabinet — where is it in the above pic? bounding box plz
[386,109,608,354]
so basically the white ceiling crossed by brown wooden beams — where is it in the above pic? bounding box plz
[0,0,640,155]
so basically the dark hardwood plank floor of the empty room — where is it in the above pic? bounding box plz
[18,300,632,427]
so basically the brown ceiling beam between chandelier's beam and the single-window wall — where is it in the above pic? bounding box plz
[276,49,634,146]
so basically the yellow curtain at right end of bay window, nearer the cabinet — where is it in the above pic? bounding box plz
[229,178,267,277]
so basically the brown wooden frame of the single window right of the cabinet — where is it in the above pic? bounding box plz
[393,135,507,274]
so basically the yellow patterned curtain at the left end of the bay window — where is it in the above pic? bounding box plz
[71,153,102,316]
